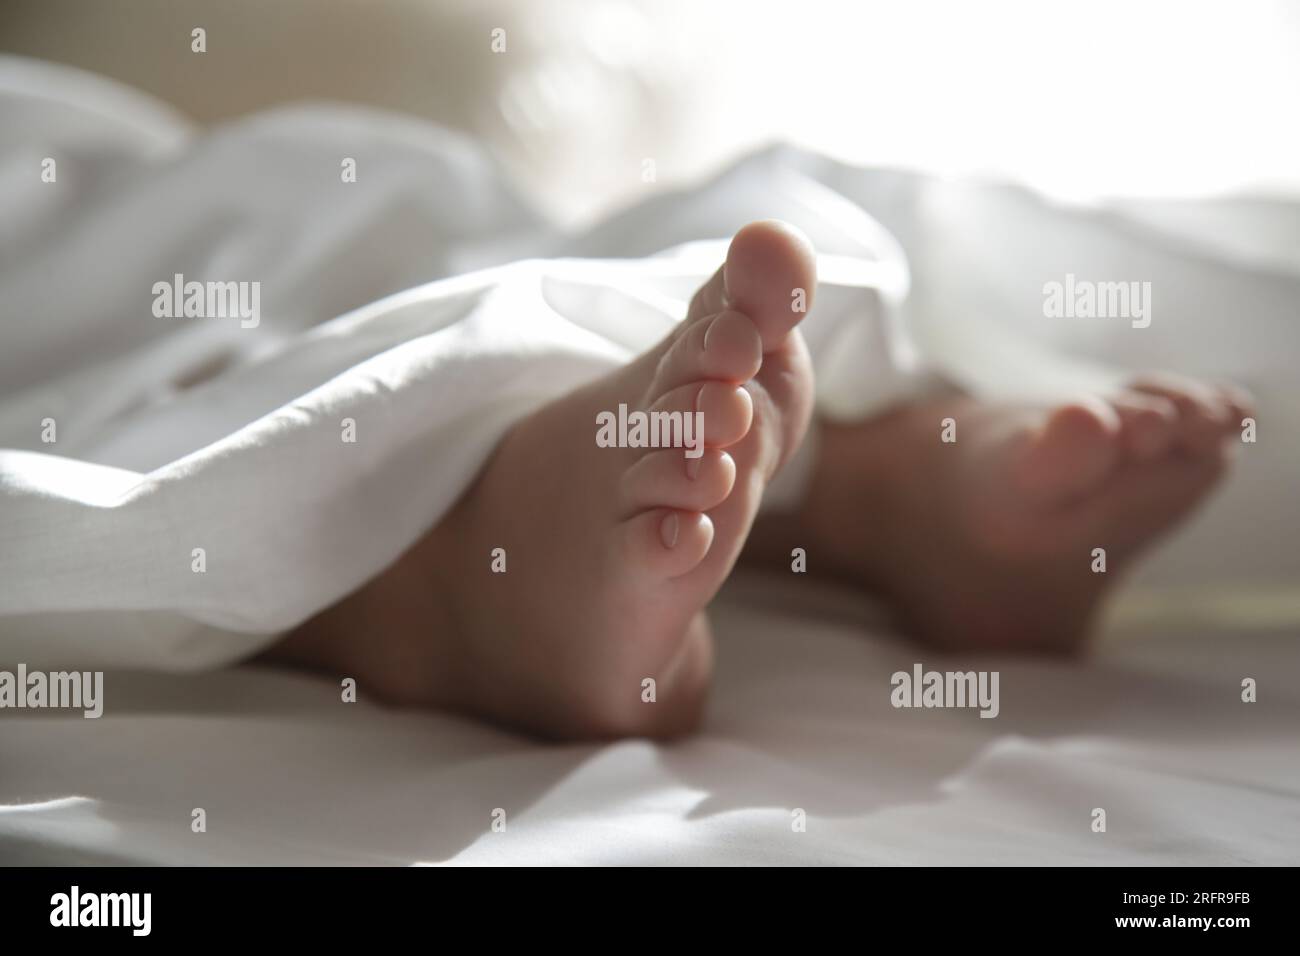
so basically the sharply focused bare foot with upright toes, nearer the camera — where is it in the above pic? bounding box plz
[262,222,816,737]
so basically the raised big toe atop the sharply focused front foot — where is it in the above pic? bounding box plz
[690,220,816,352]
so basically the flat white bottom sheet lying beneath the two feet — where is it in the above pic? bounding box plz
[0,576,1300,865]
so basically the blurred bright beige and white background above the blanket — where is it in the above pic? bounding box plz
[0,0,1300,226]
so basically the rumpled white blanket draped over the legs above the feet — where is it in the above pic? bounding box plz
[0,59,1300,669]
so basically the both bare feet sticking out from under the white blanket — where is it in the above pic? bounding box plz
[267,222,1251,739]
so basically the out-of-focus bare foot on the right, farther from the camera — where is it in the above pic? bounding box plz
[755,377,1251,650]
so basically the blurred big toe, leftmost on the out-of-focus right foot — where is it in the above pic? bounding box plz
[1018,399,1121,503]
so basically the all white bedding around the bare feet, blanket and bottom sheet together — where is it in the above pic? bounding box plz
[0,59,1300,862]
